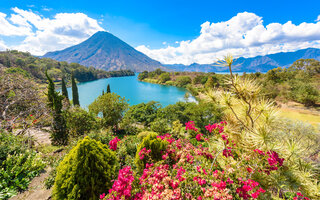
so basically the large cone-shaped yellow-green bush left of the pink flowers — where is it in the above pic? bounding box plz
[53,137,118,200]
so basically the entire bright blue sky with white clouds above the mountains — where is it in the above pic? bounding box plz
[0,0,320,64]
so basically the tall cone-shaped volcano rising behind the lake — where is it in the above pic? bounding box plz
[43,31,165,72]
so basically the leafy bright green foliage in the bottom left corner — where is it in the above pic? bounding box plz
[0,131,45,199]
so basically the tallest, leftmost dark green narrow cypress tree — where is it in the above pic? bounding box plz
[45,72,68,145]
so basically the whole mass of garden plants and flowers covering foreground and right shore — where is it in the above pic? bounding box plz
[0,56,320,200]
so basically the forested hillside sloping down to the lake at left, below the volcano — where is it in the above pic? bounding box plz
[0,50,134,83]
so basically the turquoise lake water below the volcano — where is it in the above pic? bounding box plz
[63,75,194,108]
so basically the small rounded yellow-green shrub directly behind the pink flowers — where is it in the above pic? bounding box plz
[135,133,168,171]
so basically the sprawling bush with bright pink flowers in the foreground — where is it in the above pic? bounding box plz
[97,122,302,200]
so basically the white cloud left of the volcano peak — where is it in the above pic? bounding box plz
[0,7,104,55]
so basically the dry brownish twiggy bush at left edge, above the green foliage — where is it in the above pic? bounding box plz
[0,68,47,134]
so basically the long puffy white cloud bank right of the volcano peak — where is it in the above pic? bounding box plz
[136,12,320,64]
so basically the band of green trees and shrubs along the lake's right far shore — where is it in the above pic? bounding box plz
[138,59,320,106]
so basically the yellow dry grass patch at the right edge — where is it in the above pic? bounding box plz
[280,108,320,126]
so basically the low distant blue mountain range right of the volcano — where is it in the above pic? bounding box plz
[165,48,320,72]
